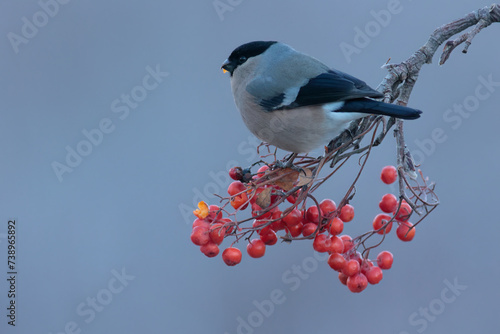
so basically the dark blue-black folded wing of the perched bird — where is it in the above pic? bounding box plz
[280,70,383,109]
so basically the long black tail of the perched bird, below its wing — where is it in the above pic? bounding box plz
[336,98,422,119]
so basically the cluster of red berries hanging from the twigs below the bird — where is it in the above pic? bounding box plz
[191,165,415,292]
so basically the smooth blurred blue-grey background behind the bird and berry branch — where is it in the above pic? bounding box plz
[0,0,500,334]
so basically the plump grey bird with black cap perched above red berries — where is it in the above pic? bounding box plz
[221,41,422,154]
